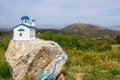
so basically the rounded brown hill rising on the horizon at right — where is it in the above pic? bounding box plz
[62,23,120,37]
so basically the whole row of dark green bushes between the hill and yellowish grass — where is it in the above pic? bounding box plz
[38,31,112,51]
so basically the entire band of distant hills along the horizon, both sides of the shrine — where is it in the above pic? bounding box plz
[0,23,120,37]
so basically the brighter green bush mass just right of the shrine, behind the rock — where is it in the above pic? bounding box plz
[38,31,85,49]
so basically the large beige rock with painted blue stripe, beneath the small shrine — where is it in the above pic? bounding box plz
[5,39,67,80]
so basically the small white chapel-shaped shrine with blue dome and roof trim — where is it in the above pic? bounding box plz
[13,16,36,41]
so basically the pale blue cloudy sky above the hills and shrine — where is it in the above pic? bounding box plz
[0,0,120,28]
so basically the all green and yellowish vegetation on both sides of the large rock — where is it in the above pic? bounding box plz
[0,31,120,80]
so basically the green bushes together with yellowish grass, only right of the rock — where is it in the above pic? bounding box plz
[38,31,120,80]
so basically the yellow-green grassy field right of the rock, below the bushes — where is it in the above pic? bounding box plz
[62,49,120,80]
